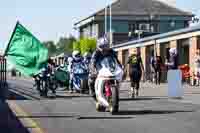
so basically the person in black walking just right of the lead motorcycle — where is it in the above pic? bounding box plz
[126,49,144,97]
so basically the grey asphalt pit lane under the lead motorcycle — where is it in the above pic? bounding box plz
[3,80,200,133]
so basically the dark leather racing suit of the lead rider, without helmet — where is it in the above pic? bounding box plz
[88,49,121,100]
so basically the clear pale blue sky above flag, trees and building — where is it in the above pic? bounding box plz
[0,0,200,48]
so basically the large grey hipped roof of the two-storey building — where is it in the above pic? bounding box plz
[75,0,193,25]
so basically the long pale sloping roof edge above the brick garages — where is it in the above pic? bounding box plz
[112,25,200,48]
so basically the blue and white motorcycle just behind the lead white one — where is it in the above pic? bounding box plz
[72,62,89,93]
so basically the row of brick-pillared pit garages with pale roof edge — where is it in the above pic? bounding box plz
[113,25,200,79]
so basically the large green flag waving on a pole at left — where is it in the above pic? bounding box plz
[5,22,48,76]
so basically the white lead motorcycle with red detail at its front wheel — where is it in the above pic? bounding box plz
[95,57,123,114]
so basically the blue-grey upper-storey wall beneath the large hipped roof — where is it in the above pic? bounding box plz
[81,16,188,42]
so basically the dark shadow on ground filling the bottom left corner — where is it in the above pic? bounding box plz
[0,101,30,133]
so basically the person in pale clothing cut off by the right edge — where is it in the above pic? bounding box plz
[194,50,200,85]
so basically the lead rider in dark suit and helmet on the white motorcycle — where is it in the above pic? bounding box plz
[88,37,121,101]
